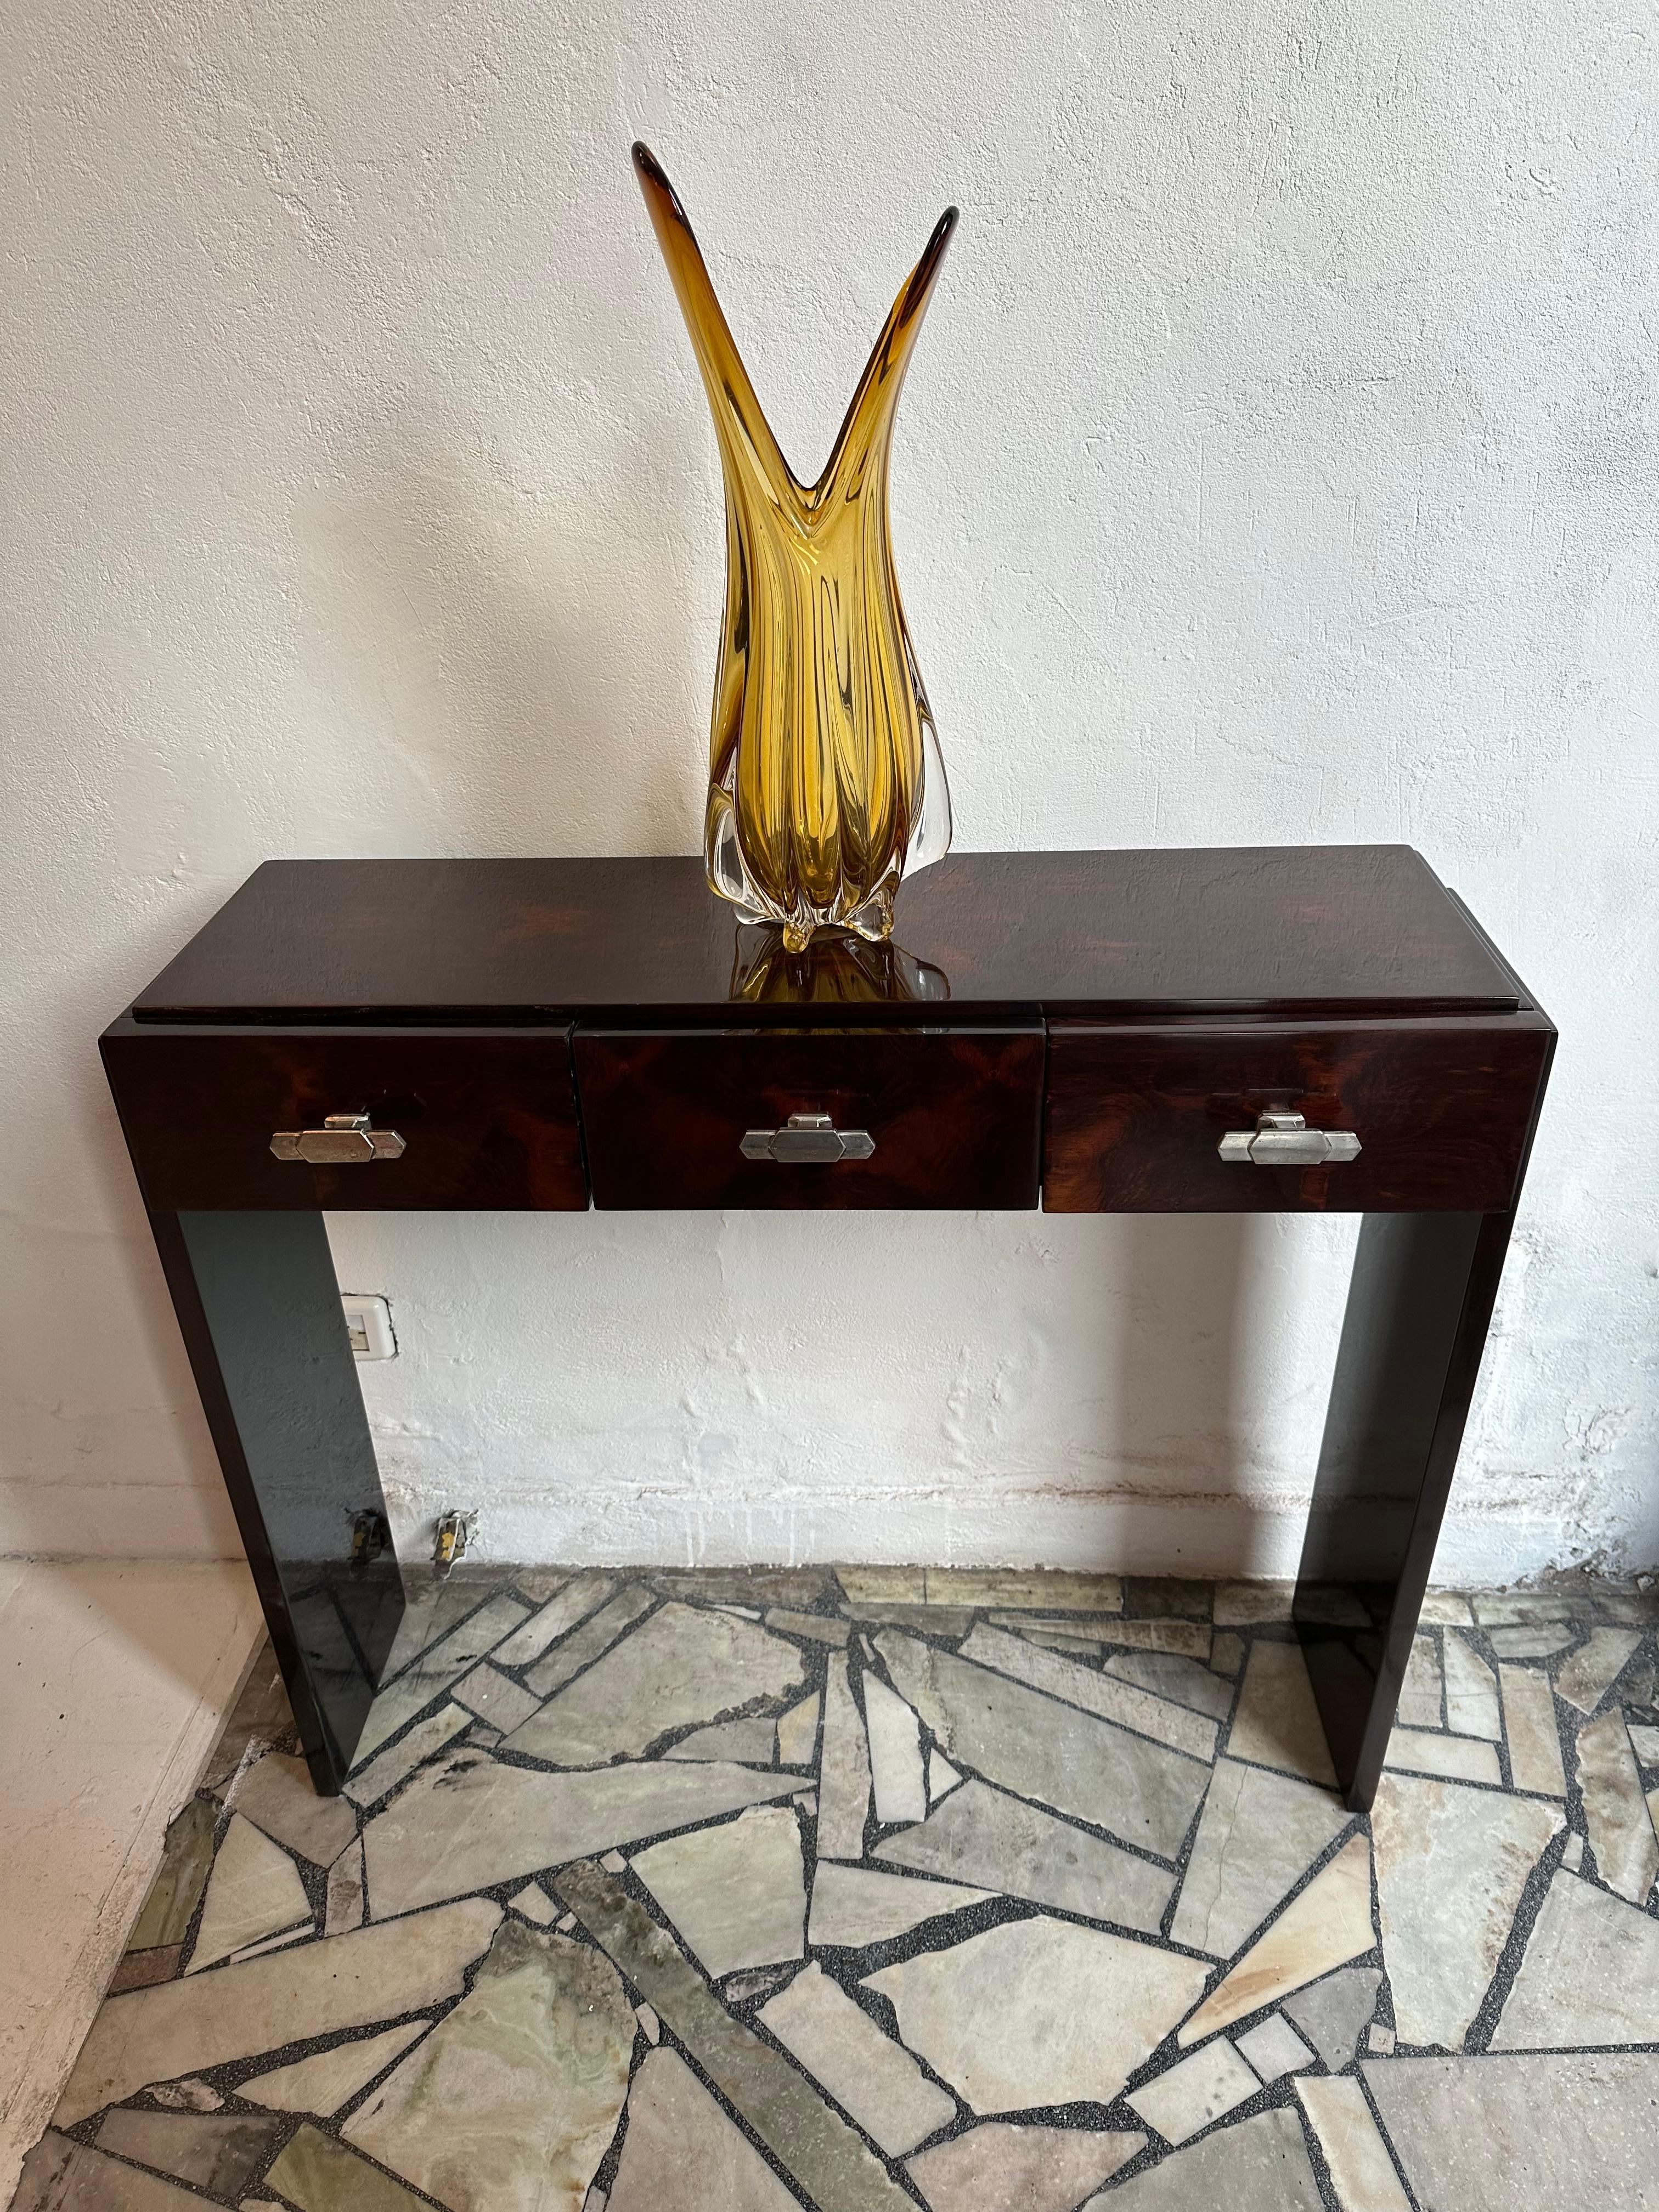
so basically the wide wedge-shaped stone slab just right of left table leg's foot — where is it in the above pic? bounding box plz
[363,1747,801,1920]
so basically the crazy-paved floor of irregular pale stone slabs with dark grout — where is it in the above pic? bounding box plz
[13,1568,1659,2212]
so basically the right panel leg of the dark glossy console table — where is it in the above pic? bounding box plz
[1294,1212,1515,1812]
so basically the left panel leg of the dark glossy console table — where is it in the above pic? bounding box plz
[150,1212,403,1794]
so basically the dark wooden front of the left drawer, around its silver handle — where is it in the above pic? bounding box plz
[104,1020,589,1212]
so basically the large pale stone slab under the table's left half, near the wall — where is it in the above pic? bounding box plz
[517,1599,805,1768]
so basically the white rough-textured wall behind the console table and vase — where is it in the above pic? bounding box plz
[0,0,1659,1577]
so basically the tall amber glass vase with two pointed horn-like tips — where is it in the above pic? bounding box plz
[633,146,956,951]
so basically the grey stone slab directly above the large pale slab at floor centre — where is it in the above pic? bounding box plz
[876,1781,1175,1936]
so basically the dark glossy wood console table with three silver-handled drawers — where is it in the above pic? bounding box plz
[101,845,1555,1807]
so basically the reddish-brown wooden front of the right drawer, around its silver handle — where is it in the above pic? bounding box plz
[1042,1013,1555,1215]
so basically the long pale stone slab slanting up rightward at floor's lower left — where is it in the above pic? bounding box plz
[53,1898,502,2123]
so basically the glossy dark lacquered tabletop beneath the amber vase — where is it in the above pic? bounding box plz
[133,845,1517,1022]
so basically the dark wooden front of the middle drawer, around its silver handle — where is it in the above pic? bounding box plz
[575,1020,1044,1207]
